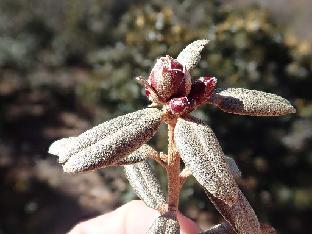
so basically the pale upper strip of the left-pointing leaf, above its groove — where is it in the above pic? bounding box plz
[49,108,160,163]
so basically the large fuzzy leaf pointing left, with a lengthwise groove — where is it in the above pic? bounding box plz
[50,108,162,173]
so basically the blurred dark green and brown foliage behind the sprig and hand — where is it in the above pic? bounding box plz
[0,0,312,233]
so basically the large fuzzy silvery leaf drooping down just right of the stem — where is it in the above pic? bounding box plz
[174,118,239,205]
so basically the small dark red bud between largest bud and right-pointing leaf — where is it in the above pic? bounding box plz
[188,76,217,108]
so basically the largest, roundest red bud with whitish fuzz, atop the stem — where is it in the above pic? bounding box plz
[145,55,191,103]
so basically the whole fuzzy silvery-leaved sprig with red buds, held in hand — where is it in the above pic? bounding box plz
[49,40,295,234]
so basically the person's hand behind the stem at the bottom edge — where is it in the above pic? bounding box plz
[68,200,200,234]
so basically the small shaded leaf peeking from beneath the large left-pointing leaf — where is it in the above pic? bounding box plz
[114,144,154,166]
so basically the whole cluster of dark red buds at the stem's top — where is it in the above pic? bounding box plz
[144,55,217,114]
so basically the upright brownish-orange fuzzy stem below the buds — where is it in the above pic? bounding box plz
[166,121,180,213]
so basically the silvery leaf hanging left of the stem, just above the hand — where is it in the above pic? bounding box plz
[124,161,166,209]
